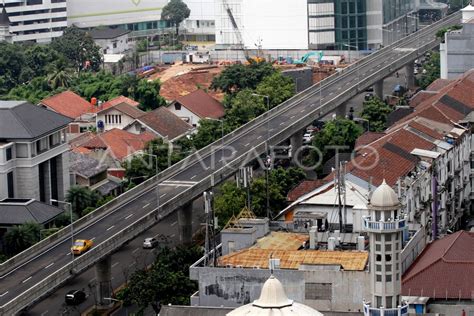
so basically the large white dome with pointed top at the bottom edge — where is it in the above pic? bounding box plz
[227,275,323,316]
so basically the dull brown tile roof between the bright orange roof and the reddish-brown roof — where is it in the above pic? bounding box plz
[138,106,193,140]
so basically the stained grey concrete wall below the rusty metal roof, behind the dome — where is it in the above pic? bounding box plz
[190,266,370,312]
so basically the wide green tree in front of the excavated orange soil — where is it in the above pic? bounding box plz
[211,61,276,94]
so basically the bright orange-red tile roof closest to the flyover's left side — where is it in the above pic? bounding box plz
[82,128,156,161]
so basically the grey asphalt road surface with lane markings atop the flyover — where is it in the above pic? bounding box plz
[0,11,460,314]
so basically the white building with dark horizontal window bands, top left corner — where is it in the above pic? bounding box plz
[4,0,67,43]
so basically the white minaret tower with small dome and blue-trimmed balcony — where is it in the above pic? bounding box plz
[364,180,408,316]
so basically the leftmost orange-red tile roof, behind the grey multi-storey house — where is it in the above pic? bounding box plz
[40,91,95,119]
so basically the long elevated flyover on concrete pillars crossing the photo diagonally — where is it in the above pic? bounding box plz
[0,13,460,315]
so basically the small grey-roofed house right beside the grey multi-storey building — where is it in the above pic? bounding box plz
[69,152,121,196]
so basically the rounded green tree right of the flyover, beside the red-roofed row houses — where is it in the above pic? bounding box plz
[310,118,362,164]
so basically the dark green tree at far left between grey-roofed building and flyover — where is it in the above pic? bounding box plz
[4,223,41,255]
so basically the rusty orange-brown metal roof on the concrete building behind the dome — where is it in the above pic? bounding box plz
[218,248,369,271]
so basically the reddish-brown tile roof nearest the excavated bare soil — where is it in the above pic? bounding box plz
[175,89,224,119]
